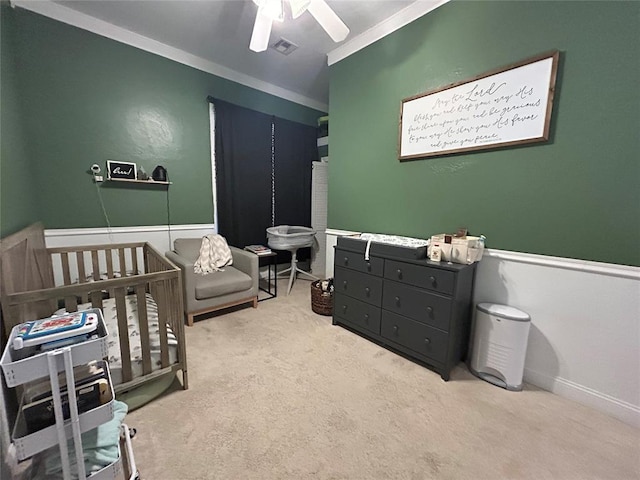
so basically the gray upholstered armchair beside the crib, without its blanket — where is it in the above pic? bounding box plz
[165,238,259,326]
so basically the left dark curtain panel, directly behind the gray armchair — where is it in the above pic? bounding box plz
[214,98,273,248]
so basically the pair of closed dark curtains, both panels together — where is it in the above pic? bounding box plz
[209,97,318,255]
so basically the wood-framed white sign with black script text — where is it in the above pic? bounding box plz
[398,50,559,161]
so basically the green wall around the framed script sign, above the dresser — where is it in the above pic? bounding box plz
[329,1,640,265]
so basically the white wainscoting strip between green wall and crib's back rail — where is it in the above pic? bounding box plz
[44,224,218,254]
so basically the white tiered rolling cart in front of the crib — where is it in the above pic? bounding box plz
[0,309,138,480]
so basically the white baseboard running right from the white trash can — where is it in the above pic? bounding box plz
[524,368,640,428]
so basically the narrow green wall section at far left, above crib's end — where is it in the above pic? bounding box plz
[0,3,39,237]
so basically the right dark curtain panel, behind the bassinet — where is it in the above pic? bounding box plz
[274,117,318,261]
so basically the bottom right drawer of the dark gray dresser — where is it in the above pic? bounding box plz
[380,310,448,363]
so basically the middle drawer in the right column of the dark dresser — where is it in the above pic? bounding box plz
[382,280,452,332]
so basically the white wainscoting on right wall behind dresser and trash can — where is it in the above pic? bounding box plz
[327,229,640,427]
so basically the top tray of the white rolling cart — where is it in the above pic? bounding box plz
[0,308,109,387]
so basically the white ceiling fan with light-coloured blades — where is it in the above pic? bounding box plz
[249,0,349,52]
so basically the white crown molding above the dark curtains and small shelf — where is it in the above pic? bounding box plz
[11,0,329,112]
